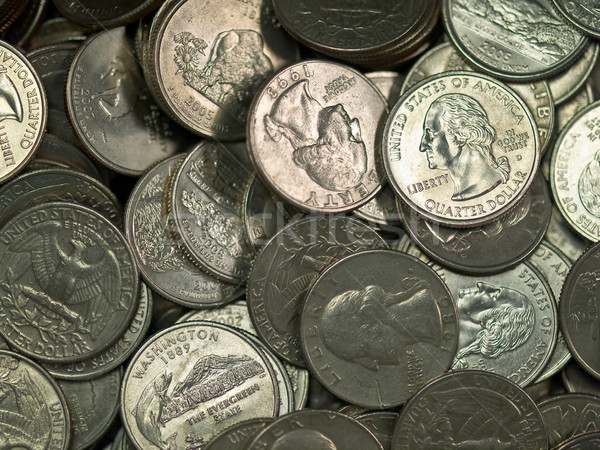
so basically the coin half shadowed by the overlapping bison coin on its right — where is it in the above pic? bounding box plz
[66,27,187,176]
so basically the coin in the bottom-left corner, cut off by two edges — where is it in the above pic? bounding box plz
[0,350,71,450]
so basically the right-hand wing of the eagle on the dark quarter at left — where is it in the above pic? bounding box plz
[68,249,121,340]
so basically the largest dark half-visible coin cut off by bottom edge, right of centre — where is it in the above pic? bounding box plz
[392,370,548,450]
